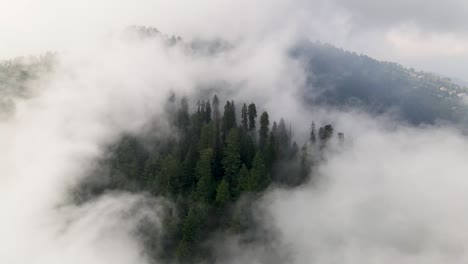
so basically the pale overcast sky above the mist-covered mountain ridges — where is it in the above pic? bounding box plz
[0,0,468,80]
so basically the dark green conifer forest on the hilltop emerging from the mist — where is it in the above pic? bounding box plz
[75,95,344,263]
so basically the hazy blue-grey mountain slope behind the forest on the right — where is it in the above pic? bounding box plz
[292,42,468,124]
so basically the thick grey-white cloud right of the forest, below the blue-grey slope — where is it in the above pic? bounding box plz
[216,114,468,264]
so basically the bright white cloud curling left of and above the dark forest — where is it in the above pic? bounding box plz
[0,14,303,264]
